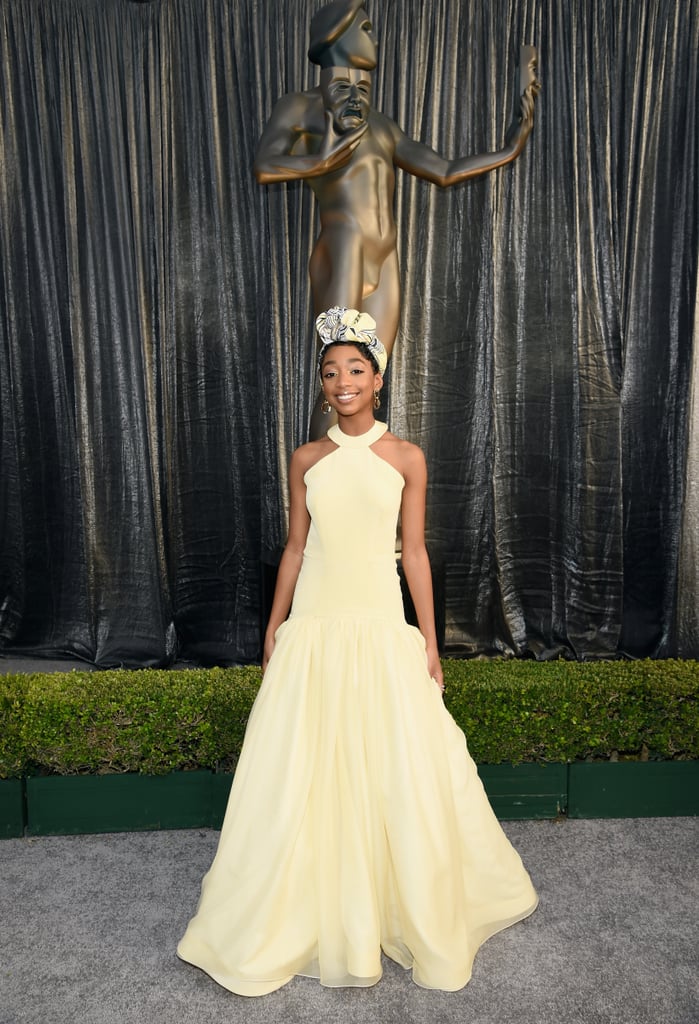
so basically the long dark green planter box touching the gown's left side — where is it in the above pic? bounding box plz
[27,771,230,836]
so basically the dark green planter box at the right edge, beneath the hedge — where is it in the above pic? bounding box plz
[568,761,699,818]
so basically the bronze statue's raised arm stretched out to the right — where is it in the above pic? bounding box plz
[394,47,540,187]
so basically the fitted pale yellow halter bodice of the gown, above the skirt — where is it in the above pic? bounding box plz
[292,422,405,620]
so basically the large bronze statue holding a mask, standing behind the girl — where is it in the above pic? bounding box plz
[255,0,540,437]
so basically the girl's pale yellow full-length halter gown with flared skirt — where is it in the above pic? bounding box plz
[177,415,537,995]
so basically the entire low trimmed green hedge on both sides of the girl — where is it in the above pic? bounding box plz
[0,660,699,778]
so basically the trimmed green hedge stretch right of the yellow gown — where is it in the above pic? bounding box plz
[443,659,699,764]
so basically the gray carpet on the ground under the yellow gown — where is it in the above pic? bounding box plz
[0,818,699,1024]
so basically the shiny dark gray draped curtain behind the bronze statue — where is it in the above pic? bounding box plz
[0,0,699,666]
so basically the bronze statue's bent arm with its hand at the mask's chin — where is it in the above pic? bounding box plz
[255,93,366,185]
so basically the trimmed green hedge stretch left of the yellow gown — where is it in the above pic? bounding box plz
[0,667,260,778]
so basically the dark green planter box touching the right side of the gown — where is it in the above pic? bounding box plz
[478,764,568,821]
